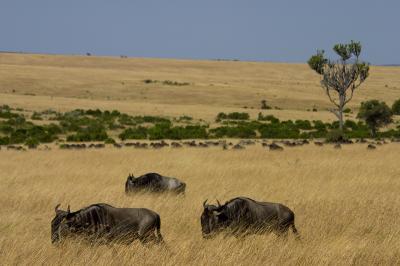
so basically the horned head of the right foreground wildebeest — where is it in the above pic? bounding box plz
[200,200,223,238]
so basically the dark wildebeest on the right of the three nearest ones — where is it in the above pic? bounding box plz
[201,197,298,238]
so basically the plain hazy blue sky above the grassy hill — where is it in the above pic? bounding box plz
[0,0,400,64]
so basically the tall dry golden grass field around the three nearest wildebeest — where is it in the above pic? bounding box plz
[0,144,400,265]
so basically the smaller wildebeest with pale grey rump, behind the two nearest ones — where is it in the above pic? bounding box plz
[125,173,186,193]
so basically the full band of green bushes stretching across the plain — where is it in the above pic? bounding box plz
[0,106,400,145]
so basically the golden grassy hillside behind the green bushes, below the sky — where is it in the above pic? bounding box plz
[0,53,400,121]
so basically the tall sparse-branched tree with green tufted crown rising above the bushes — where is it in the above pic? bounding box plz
[308,41,369,131]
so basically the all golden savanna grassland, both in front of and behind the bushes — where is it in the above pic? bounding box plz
[0,53,400,265]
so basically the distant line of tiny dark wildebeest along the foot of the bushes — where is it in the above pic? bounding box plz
[0,138,400,151]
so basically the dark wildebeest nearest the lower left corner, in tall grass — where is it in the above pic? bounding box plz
[51,203,163,244]
